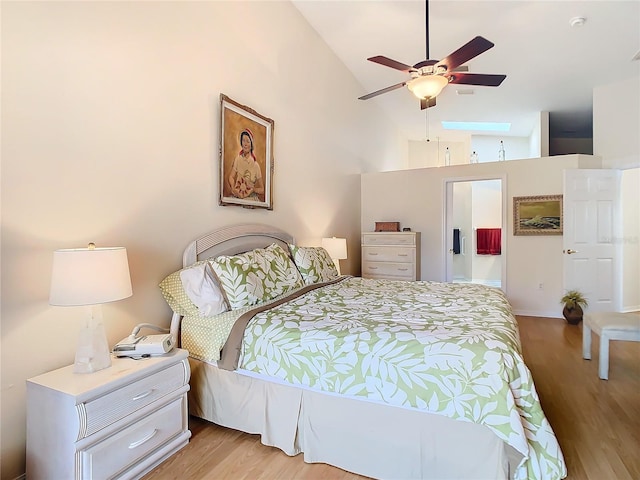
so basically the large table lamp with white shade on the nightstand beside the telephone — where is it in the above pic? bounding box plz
[49,243,133,373]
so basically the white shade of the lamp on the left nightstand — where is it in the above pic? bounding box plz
[49,247,133,306]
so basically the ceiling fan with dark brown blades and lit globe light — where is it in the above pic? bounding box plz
[359,0,507,110]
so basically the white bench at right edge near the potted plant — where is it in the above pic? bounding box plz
[582,312,640,380]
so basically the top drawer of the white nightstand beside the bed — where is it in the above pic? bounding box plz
[77,362,188,439]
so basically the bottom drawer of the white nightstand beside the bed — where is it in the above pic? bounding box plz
[76,397,185,479]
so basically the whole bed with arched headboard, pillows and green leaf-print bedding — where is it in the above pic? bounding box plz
[160,224,566,480]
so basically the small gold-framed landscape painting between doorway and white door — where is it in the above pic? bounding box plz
[513,195,564,235]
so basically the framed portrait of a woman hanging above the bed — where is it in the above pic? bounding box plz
[220,94,274,210]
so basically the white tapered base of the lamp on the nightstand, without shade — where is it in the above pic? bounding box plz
[73,305,111,373]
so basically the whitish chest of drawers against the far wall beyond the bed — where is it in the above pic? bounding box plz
[362,232,420,281]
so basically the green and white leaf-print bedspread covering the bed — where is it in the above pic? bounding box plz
[240,278,566,479]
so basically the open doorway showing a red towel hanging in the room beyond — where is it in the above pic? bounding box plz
[444,176,507,291]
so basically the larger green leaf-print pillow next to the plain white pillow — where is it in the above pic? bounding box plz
[210,244,304,310]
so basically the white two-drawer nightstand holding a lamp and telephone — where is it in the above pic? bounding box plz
[27,349,191,480]
